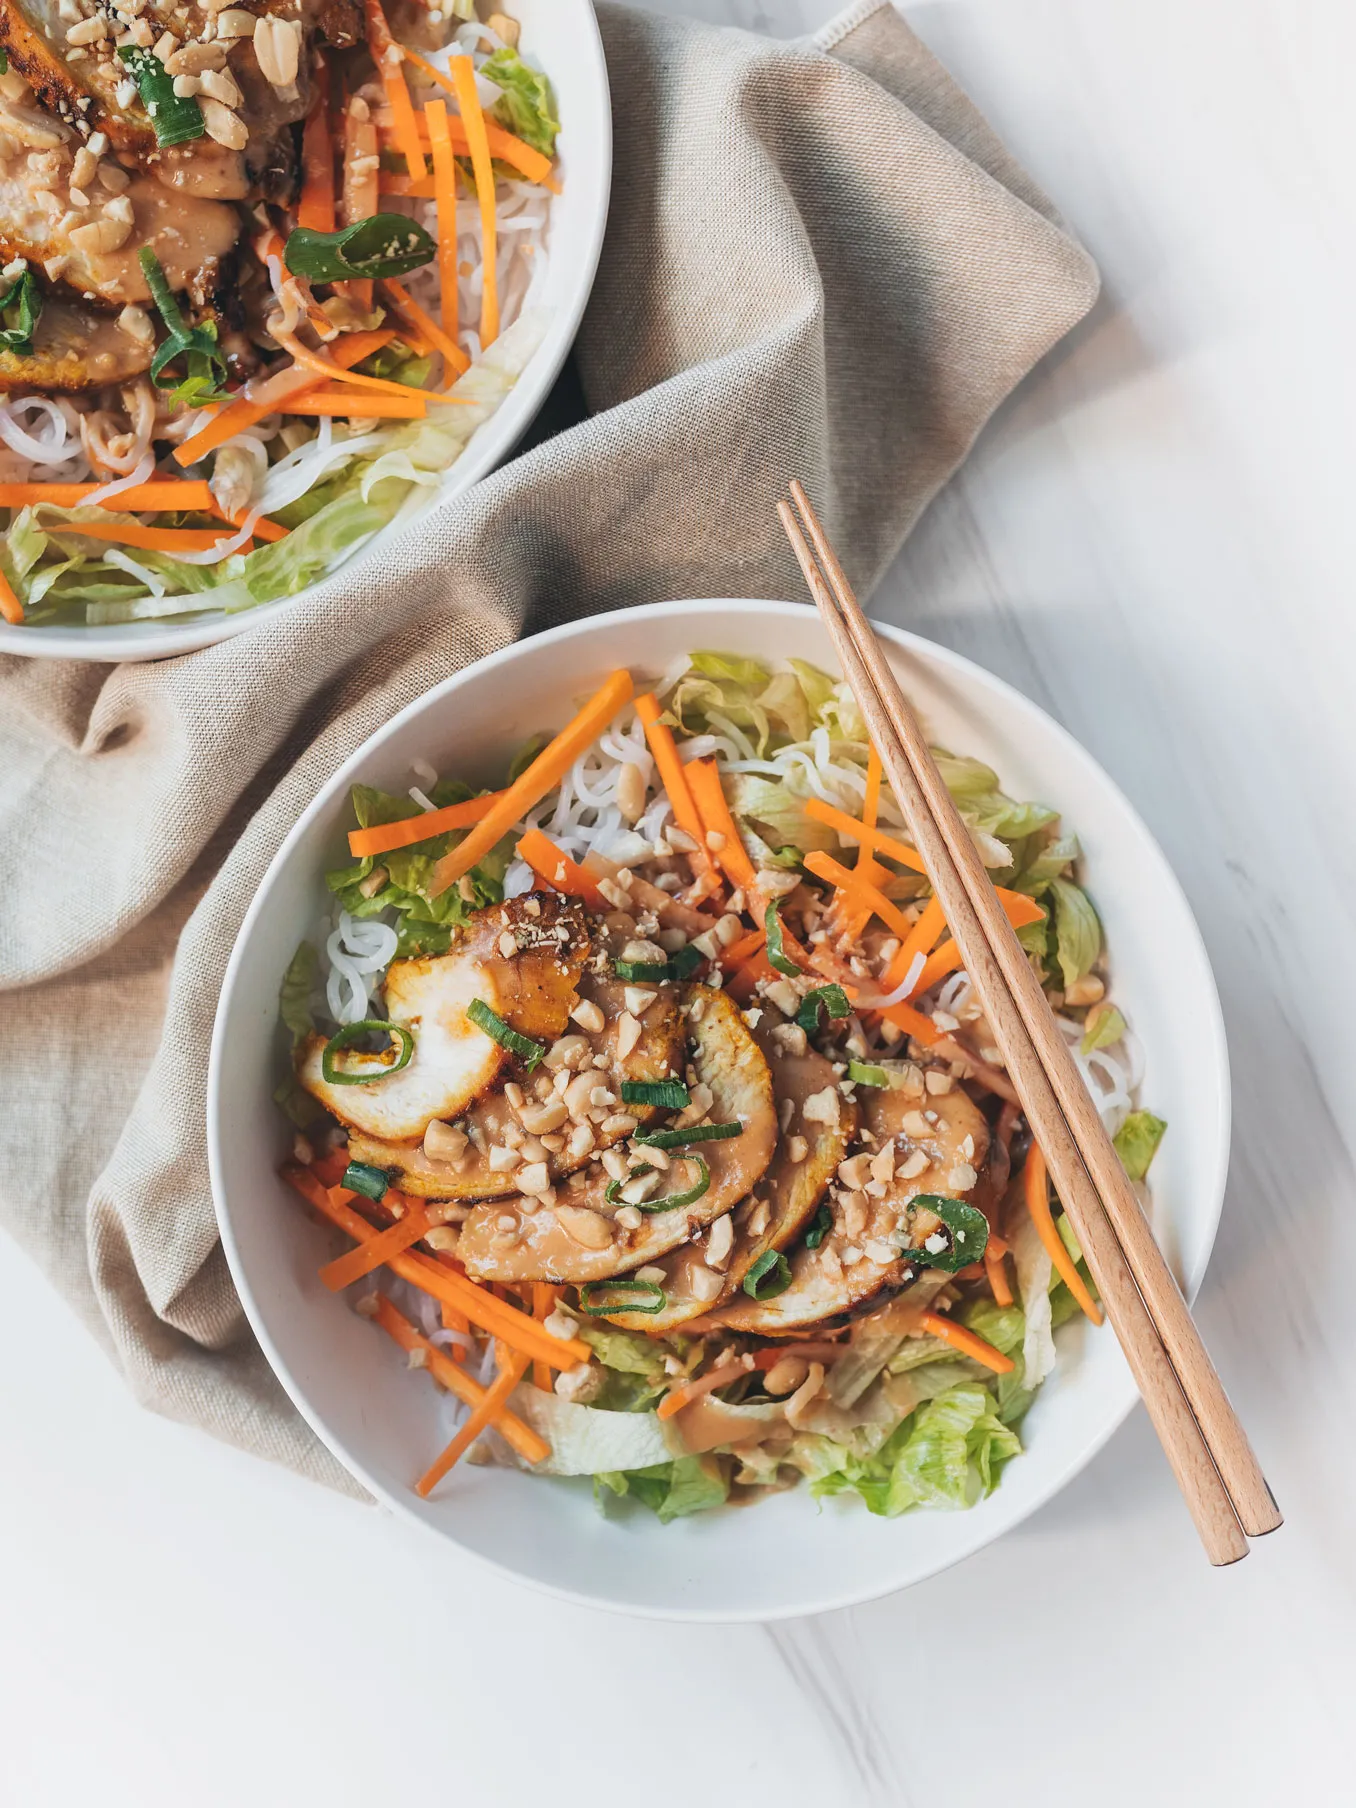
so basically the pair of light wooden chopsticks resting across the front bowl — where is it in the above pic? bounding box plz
[779,485,1280,1564]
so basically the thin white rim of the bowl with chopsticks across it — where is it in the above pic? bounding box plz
[206,597,1231,1625]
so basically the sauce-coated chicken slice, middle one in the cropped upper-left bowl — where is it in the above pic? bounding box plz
[0,101,240,307]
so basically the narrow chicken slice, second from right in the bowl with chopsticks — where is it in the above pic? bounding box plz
[611,1009,857,1332]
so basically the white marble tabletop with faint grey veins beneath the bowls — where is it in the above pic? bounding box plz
[0,0,1356,1808]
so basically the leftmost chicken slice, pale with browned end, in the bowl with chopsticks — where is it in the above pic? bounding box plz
[297,893,589,1143]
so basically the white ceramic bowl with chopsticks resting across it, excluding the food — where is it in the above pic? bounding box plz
[208,602,1229,1620]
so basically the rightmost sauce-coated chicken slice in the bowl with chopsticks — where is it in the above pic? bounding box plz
[712,1087,989,1338]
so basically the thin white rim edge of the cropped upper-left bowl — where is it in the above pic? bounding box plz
[0,0,613,665]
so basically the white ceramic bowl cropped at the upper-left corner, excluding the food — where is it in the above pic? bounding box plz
[0,0,613,660]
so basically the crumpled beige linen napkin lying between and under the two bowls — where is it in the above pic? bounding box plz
[0,4,1097,1486]
